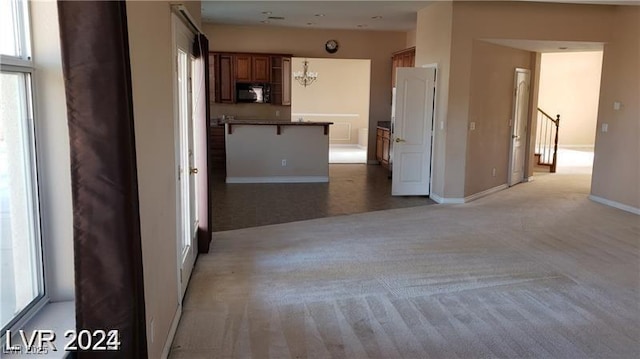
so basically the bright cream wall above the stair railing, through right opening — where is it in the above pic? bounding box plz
[538,51,602,147]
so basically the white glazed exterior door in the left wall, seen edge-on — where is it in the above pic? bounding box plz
[172,14,198,297]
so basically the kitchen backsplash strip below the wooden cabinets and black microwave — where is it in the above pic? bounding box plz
[211,103,291,122]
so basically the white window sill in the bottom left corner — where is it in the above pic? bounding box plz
[2,301,76,359]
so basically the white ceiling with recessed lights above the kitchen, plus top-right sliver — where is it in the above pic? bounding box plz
[202,0,640,31]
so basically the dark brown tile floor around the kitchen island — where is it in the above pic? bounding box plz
[212,164,435,232]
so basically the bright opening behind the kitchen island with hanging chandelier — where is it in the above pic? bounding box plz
[291,57,371,164]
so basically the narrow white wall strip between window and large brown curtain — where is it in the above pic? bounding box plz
[30,1,75,302]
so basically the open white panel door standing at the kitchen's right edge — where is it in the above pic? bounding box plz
[391,67,436,196]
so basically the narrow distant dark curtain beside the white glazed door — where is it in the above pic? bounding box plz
[193,34,213,253]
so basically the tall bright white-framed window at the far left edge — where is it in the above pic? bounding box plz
[0,0,45,335]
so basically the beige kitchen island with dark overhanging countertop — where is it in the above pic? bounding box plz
[224,120,333,183]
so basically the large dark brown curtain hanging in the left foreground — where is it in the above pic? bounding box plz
[58,1,147,358]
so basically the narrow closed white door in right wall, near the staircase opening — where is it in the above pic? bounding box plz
[509,69,531,186]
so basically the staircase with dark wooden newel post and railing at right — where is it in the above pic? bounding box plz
[535,108,560,173]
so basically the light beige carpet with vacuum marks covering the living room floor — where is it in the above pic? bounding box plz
[170,174,640,358]
